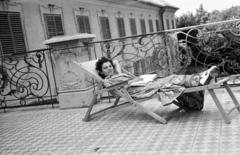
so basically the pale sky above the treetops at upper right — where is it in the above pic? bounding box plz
[165,0,240,17]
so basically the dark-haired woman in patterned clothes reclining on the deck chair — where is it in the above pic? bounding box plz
[96,57,218,110]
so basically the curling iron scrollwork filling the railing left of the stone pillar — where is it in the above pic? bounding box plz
[0,50,56,108]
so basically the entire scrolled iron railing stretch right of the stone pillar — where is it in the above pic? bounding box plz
[89,19,240,76]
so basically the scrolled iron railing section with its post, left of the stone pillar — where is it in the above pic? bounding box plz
[0,49,57,111]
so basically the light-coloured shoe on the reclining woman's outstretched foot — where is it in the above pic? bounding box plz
[200,66,219,85]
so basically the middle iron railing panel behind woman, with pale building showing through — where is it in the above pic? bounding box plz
[97,33,169,76]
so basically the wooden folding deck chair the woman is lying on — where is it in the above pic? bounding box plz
[73,60,240,124]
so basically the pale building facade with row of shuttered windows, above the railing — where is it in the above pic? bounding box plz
[0,0,177,55]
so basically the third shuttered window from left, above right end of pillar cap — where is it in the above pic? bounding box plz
[77,15,91,33]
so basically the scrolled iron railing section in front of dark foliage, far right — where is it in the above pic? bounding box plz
[178,22,240,75]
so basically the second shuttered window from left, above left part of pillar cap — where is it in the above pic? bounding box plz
[44,13,64,38]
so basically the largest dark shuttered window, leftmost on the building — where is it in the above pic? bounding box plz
[0,11,26,55]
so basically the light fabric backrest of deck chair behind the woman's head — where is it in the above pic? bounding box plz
[73,59,122,81]
